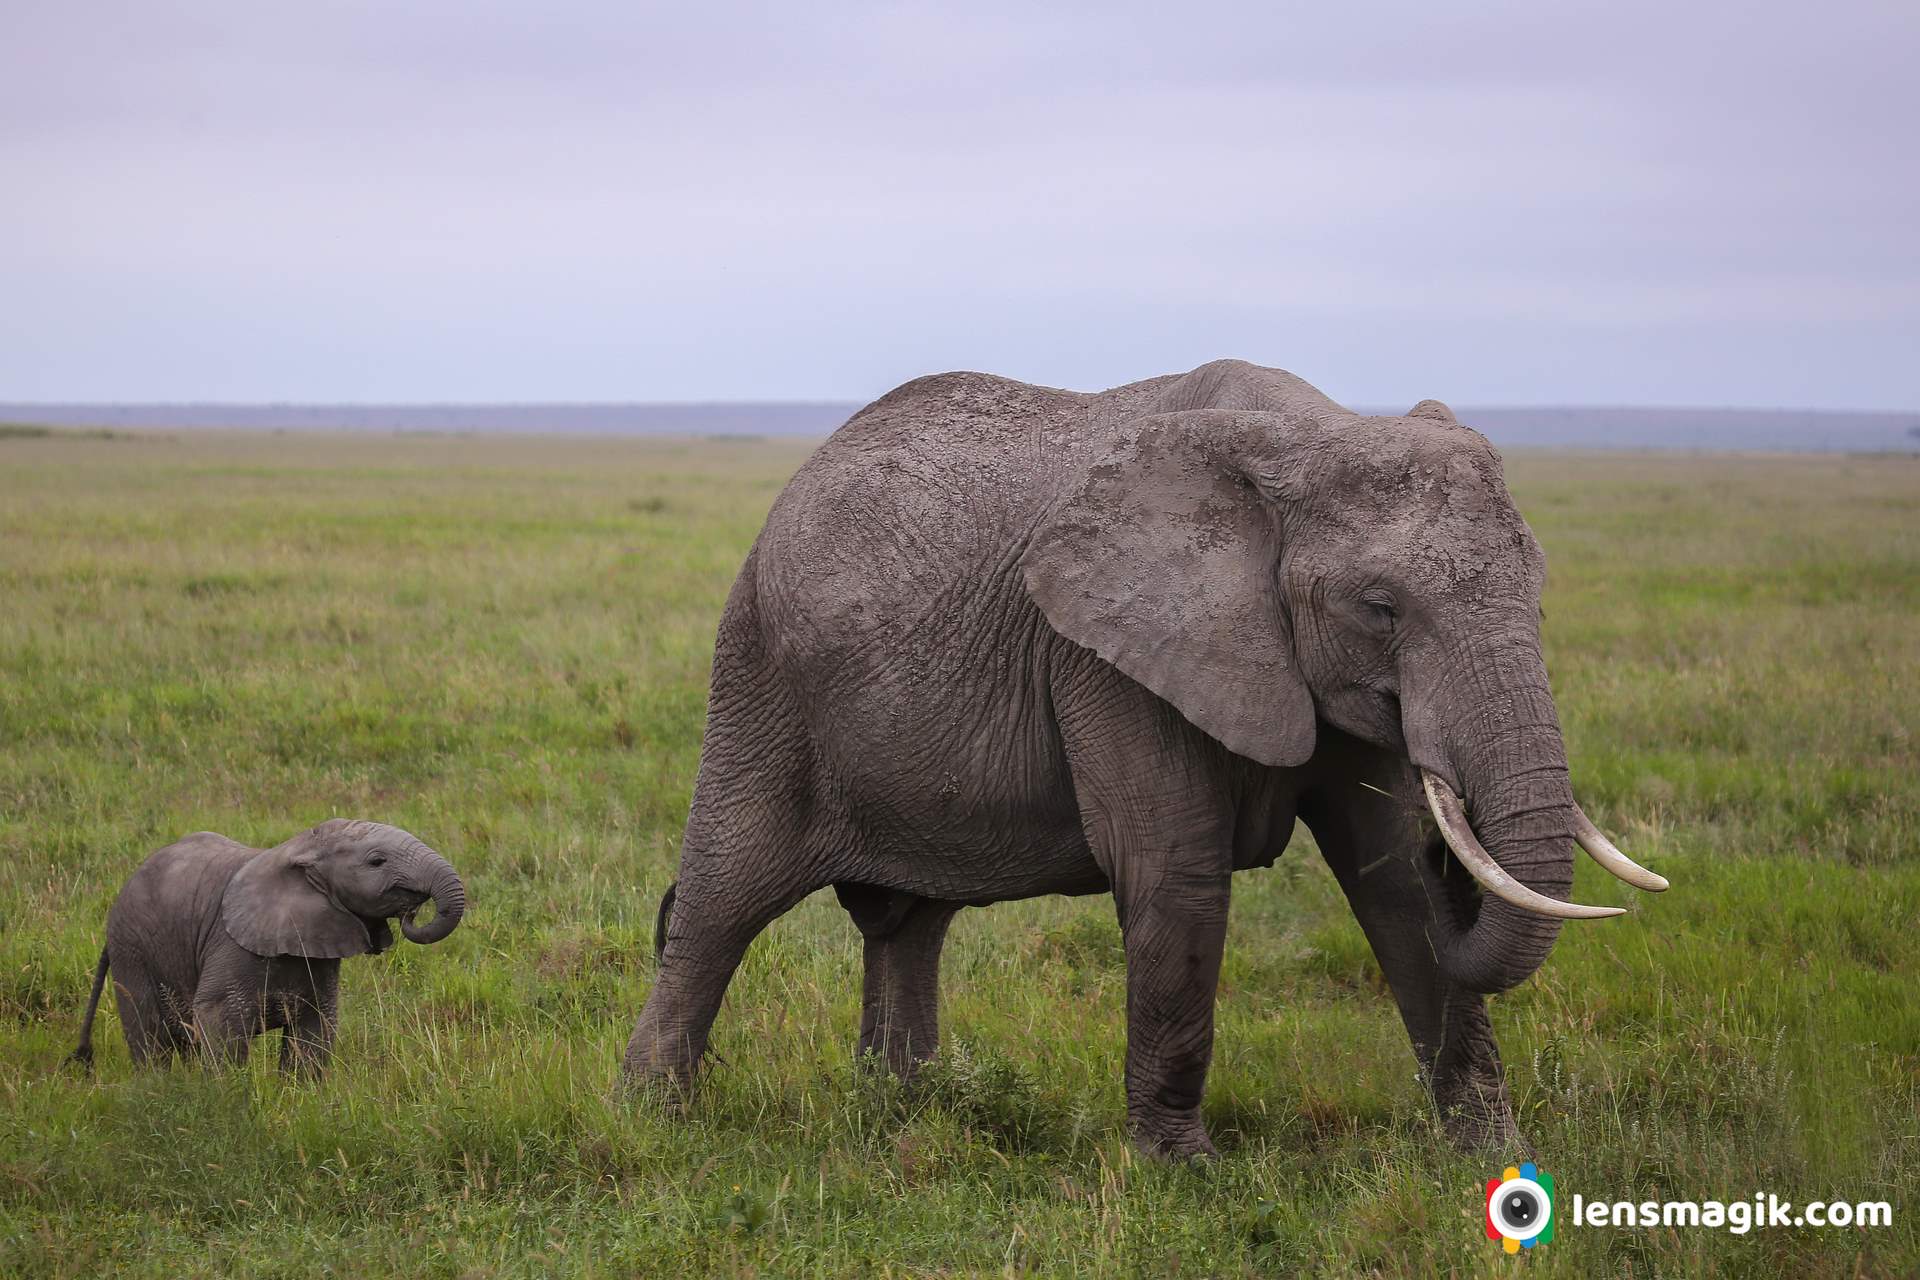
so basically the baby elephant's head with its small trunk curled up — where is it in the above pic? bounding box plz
[221,818,467,960]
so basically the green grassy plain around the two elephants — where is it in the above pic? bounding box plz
[0,434,1920,1276]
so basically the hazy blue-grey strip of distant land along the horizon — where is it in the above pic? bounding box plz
[0,401,1920,453]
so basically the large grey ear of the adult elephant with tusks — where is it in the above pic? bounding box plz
[1020,411,1315,766]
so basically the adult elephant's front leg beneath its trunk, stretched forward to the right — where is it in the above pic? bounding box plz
[1300,739,1526,1151]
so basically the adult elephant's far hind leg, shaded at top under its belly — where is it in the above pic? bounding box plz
[833,885,960,1077]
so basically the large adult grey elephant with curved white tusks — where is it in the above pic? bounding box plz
[624,361,1665,1157]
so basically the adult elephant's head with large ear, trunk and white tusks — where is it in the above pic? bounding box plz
[1021,370,1667,992]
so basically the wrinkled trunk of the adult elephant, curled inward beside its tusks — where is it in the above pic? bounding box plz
[1428,652,1582,994]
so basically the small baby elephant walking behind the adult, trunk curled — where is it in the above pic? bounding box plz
[73,818,467,1071]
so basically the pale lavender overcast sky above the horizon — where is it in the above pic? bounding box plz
[0,0,1920,411]
